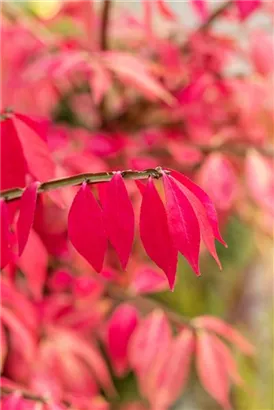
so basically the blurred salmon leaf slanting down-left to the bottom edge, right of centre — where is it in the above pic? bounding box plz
[150,329,195,409]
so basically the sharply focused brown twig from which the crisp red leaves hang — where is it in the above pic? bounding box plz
[0,167,168,201]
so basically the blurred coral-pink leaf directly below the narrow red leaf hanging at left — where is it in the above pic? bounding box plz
[18,229,48,300]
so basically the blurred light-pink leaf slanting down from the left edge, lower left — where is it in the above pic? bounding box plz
[0,306,36,360]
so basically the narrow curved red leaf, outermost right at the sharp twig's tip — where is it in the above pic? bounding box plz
[167,168,226,246]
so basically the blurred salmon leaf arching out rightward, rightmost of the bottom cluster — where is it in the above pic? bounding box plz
[194,316,255,355]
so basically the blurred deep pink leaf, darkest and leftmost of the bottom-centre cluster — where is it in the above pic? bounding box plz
[106,303,138,377]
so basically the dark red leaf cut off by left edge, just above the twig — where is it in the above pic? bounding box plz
[0,119,27,190]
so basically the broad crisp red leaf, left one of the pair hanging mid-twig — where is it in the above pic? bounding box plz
[68,183,107,272]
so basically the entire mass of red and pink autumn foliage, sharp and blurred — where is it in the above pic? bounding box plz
[0,0,274,410]
